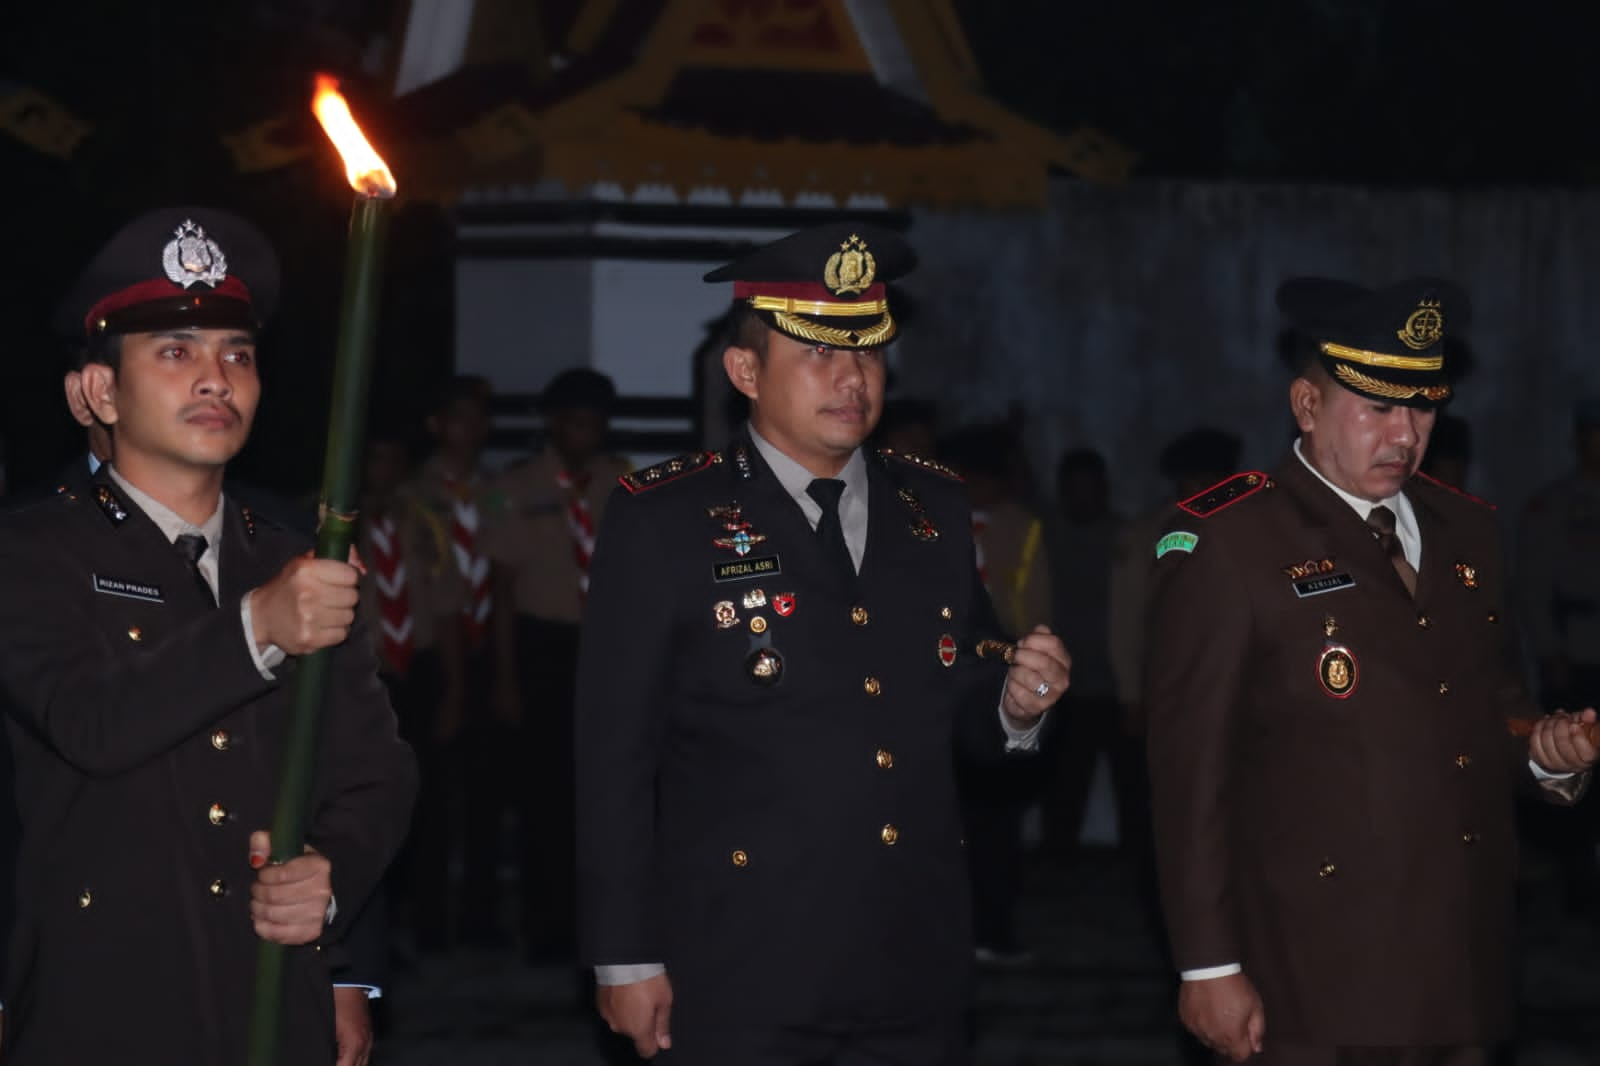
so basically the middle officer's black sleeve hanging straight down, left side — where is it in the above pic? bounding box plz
[574,490,675,965]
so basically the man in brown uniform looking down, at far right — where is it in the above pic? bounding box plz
[1144,279,1595,1066]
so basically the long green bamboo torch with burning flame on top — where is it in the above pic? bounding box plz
[250,77,395,1066]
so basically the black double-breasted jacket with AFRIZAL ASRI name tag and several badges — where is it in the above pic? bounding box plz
[578,440,1005,1031]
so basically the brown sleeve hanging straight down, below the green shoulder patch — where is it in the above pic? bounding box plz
[1144,530,1251,972]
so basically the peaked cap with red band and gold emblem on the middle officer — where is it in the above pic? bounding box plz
[706,222,915,347]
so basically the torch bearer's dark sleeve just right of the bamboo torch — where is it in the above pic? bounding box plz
[306,611,416,940]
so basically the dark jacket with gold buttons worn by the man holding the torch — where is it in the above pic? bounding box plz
[0,472,414,1066]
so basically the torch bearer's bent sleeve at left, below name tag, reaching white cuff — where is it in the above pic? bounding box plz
[0,530,274,776]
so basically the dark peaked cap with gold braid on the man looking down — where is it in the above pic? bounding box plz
[1278,277,1470,407]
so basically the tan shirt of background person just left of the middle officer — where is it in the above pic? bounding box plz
[488,450,629,623]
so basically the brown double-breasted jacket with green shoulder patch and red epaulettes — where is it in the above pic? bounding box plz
[1146,456,1574,1045]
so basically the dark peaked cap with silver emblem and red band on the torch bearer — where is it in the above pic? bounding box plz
[58,206,278,338]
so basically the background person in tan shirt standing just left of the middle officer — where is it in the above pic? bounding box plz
[486,367,629,962]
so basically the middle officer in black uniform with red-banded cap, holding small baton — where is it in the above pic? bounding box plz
[576,224,1069,1066]
